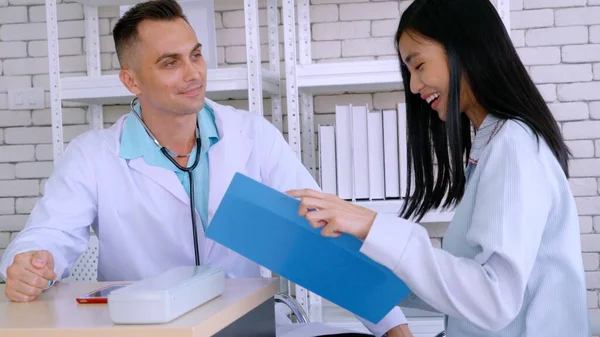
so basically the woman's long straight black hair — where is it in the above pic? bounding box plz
[395,0,570,220]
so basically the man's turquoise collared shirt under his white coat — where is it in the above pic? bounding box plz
[119,104,219,230]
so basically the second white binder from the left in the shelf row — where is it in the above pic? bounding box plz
[335,105,354,200]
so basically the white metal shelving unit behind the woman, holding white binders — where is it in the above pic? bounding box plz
[282,0,510,328]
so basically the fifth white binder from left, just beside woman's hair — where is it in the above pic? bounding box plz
[383,110,400,198]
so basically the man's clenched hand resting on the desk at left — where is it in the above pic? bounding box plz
[4,250,56,302]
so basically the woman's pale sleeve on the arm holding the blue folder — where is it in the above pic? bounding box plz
[361,140,552,331]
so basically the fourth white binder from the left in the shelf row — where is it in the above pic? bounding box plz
[367,110,385,200]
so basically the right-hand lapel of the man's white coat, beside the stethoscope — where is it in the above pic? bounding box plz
[204,100,252,261]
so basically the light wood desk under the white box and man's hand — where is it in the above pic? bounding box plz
[0,278,279,337]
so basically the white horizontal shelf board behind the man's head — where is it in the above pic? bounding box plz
[60,67,279,104]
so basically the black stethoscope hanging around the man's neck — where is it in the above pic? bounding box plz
[130,97,201,266]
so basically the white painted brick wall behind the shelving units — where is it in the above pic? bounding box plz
[0,0,600,318]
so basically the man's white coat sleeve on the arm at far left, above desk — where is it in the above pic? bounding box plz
[0,136,97,280]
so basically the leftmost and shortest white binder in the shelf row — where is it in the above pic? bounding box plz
[319,125,337,194]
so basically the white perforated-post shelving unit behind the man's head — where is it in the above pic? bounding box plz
[46,0,283,163]
